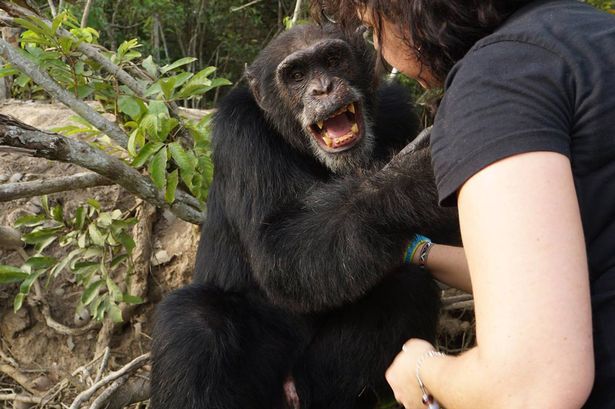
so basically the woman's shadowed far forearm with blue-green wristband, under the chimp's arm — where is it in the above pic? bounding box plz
[412,243,472,293]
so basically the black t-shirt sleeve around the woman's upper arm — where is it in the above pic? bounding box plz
[431,40,574,206]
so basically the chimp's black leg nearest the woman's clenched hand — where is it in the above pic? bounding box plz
[293,267,440,409]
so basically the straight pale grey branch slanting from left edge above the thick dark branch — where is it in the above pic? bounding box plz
[0,38,128,148]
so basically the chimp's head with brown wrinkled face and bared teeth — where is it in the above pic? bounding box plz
[248,26,374,173]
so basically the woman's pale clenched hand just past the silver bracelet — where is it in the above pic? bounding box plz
[386,338,435,409]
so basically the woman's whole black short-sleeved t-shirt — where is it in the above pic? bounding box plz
[431,0,615,409]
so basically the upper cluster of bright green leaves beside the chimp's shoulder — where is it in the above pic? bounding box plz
[0,11,231,203]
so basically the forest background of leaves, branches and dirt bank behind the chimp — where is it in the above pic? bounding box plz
[0,0,614,409]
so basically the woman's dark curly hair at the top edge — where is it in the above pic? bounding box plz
[312,0,533,84]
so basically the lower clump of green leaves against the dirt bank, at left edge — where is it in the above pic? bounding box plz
[0,197,142,322]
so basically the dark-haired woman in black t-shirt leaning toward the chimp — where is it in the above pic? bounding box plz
[318,0,615,409]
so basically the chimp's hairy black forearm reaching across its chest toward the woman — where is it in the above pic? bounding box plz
[255,145,458,311]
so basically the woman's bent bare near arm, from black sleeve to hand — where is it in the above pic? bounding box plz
[387,152,594,409]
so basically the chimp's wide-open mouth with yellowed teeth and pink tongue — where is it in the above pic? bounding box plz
[309,102,363,153]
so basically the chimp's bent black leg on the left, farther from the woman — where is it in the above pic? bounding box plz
[151,285,309,409]
